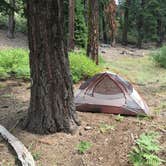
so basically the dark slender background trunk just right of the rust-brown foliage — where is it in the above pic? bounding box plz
[122,0,130,45]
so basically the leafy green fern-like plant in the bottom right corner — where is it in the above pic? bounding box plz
[129,132,164,166]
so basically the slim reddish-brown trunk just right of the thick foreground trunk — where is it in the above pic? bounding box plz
[68,0,75,51]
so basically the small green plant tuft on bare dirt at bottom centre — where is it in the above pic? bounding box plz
[77,141,92,154]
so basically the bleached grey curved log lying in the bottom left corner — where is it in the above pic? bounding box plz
[0,125,35,166]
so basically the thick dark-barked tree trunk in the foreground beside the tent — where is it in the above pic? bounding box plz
[26,0,78,134]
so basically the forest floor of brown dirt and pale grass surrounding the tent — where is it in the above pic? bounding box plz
[0,32,166,166]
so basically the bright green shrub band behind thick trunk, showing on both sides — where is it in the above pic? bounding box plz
[0,48,100,83]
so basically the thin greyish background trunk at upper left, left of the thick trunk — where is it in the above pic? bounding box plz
[7,0,15,39]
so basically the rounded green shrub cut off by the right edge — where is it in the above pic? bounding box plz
[152,46,166,68]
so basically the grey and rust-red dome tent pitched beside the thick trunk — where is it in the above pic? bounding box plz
[75,72,149,115]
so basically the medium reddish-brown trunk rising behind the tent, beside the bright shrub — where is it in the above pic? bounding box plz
[87,0,99,65]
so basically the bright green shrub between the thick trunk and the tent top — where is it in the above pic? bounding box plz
[69,51,100,83]
